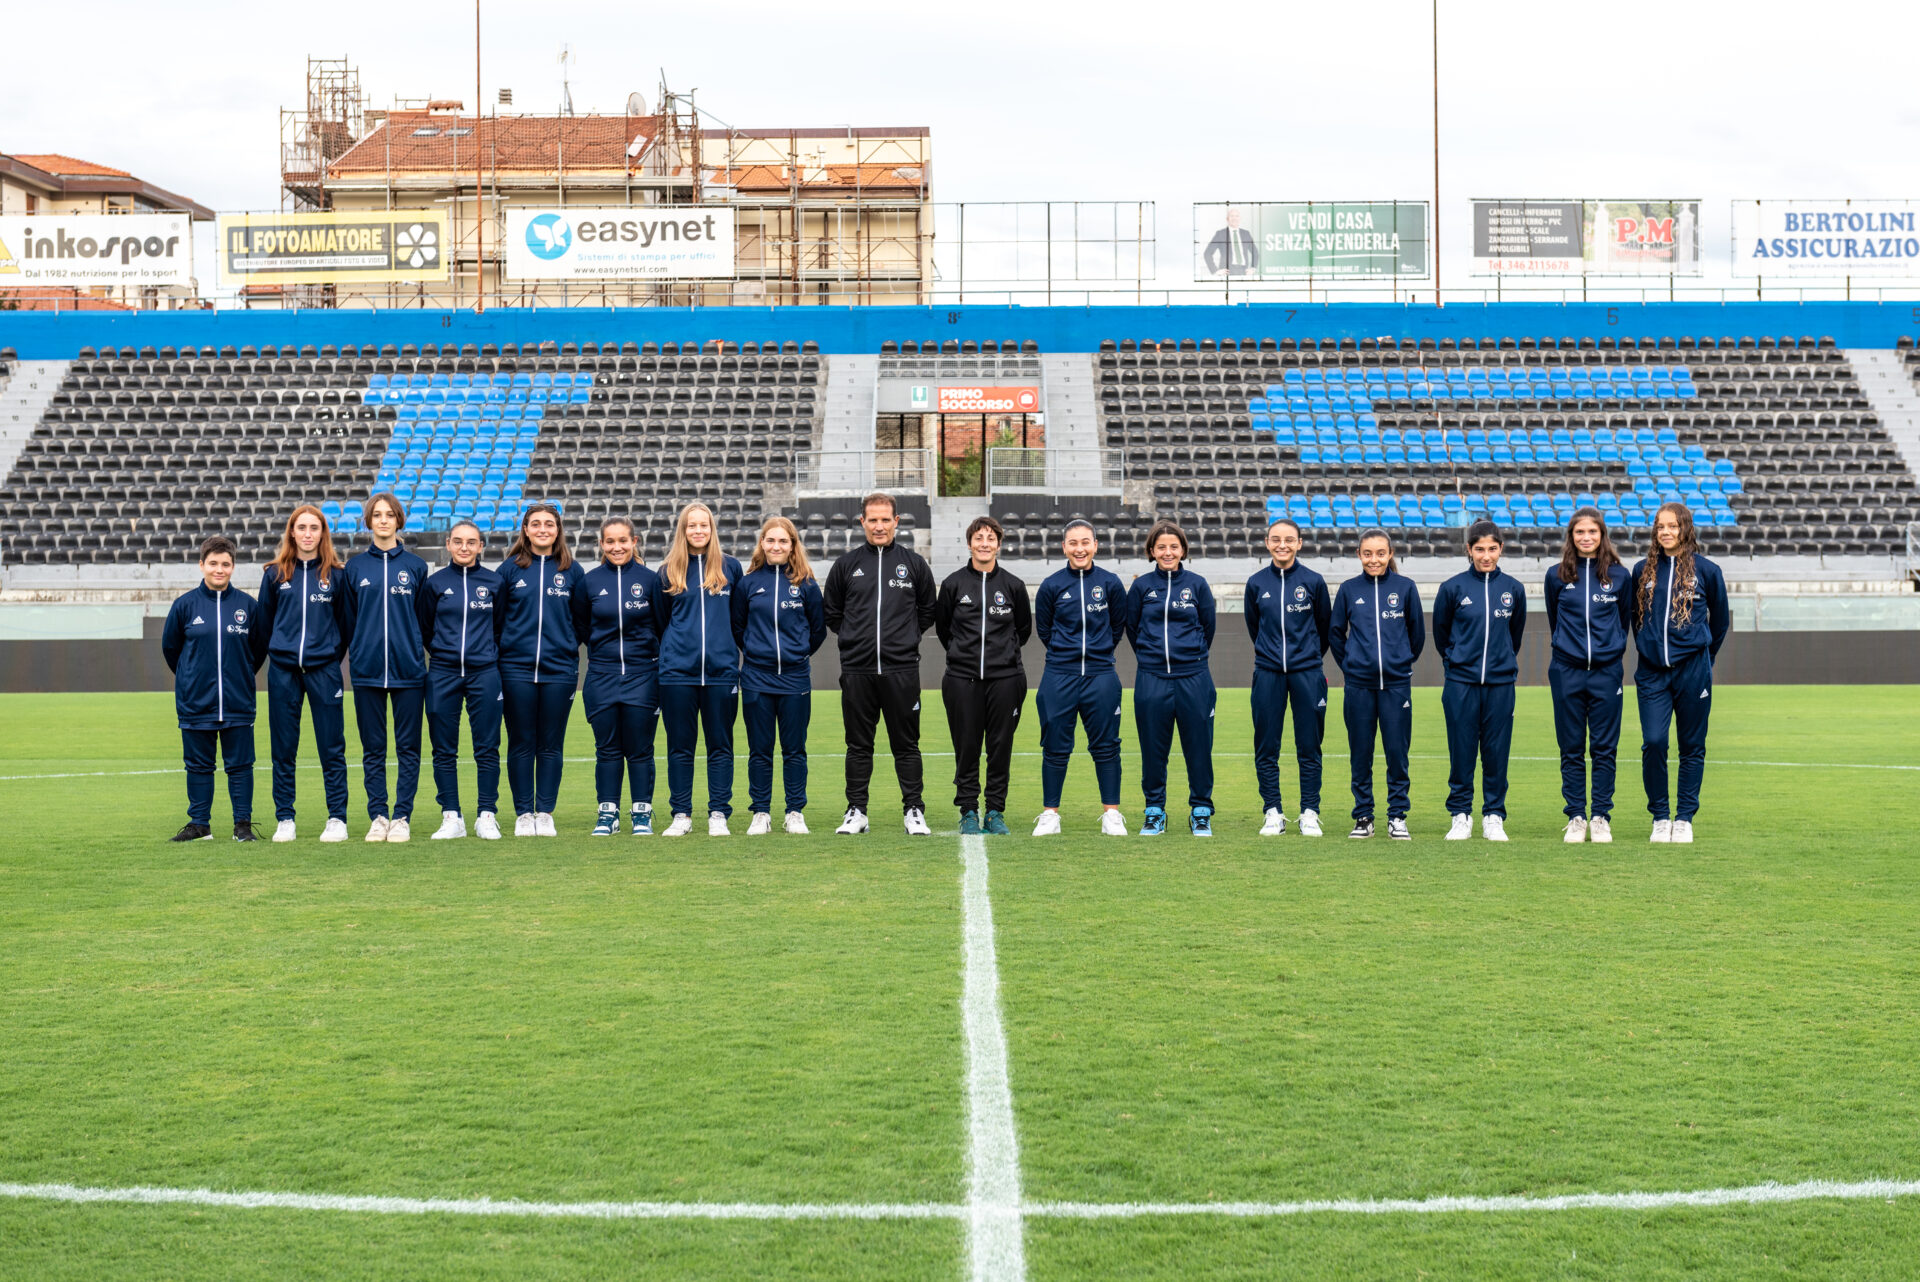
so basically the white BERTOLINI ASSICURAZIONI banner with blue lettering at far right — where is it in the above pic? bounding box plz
[1734,200,1920,276]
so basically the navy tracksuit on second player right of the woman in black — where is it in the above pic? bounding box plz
[1127,564,1215,812]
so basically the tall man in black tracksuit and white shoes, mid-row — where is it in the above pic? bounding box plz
[822,493,935,837]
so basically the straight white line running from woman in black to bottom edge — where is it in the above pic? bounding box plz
[960,837,1027,1282]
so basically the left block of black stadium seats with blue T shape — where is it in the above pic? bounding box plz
[0,342,820,564]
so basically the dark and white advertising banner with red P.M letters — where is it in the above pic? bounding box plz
[1473,200,1699,276]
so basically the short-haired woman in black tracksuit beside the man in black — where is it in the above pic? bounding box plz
[933,516,1033,835]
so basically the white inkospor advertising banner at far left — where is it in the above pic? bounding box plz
[0,213,194,290]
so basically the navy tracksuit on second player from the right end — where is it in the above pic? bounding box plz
[1544,557,1634,819]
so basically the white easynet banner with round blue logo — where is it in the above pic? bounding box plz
[507,205,733,280]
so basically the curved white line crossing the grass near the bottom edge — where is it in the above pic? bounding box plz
[0,1180,1920,1224]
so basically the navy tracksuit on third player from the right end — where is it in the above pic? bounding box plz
[1434,568,1526,818]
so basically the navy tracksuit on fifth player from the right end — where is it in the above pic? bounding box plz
[1246,560,1332,812]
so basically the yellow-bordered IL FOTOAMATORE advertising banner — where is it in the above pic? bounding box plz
[217,209,447,286]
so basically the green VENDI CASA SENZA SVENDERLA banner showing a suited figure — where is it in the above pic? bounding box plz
[1194,200,1428,280]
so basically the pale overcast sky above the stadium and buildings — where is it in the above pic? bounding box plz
[0,0,1920,294]
